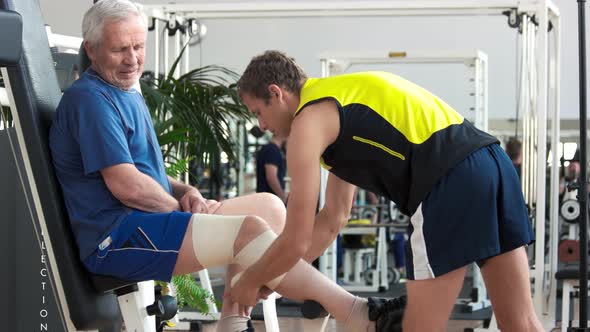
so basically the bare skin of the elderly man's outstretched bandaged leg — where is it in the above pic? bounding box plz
[174,216,374,331]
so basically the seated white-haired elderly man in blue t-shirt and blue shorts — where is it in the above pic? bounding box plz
[50,0,400,331]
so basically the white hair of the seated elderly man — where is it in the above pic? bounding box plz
[82,0,147,47]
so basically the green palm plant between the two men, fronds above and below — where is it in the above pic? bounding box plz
[141,46,249,313]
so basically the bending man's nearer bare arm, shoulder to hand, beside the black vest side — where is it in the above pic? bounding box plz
[240,101,339,287]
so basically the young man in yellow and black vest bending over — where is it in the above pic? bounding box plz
[236,51,542,332]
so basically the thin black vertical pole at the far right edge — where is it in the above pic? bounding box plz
[568,0,590,331]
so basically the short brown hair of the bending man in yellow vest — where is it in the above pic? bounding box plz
[238,50,307,103]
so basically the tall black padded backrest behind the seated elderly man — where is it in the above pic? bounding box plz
[0,0,136,331]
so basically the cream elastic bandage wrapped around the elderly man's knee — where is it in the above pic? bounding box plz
[191,214,285,290]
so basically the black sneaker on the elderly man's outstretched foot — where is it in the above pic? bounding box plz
[367,295,406,332]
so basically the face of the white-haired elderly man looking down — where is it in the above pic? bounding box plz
[86,17,146,90]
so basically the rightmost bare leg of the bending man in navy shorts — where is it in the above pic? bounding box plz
[481,247,543,332]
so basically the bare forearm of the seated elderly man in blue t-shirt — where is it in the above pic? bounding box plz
[100,164,180,212]
